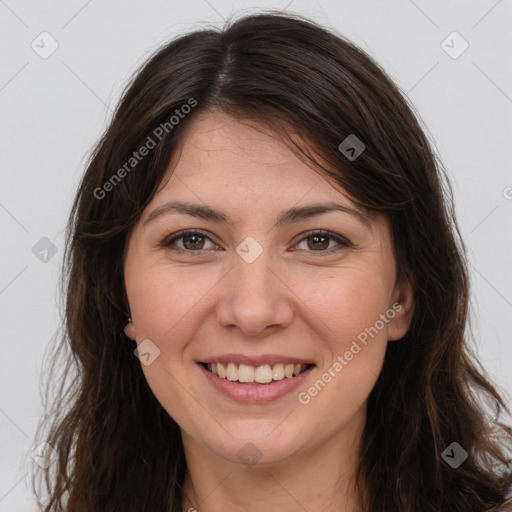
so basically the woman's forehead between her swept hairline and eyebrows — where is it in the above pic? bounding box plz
[159,111,352,204]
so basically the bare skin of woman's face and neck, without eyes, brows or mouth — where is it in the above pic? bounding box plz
[124,111,414,512]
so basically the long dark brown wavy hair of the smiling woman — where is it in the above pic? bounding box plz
[33,11,512,512]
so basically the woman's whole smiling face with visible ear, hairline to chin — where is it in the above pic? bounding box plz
[124,112,413,463]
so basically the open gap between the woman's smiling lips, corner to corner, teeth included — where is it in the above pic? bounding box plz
[200,362,315,386]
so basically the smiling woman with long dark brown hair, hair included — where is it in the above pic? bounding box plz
[32,13,512,512]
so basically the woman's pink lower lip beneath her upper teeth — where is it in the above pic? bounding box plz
[198,364,315,404]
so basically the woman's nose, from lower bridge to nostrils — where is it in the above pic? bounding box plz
[216,250,294,336]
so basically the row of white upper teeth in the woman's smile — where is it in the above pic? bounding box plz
[207,363,307,384]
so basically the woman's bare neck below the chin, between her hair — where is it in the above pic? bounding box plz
[182,411,365,512]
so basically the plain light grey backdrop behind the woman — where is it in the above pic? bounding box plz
[0,0,512,512]
